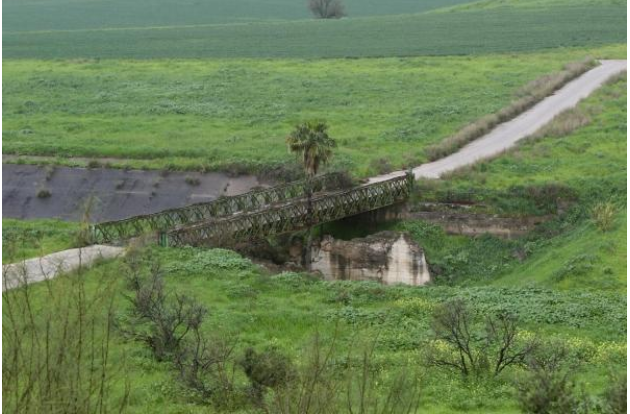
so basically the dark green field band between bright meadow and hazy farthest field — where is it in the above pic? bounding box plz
[3,1,627,59]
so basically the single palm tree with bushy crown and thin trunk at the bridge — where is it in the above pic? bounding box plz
[287,121,337,269]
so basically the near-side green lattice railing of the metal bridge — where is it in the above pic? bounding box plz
[159,174,414,246]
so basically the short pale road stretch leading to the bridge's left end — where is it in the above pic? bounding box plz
[2,245,125,292]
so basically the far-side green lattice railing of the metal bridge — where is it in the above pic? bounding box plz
[91,173,350,243]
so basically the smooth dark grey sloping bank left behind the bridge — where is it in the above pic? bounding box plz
[2,164,263,221]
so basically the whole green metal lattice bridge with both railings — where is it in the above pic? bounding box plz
[91,173,414,247]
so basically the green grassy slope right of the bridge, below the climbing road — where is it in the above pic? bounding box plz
[412,74,627,291]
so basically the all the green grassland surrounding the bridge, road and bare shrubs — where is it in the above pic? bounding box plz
[2,0,627,414]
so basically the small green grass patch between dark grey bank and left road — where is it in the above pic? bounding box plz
[2,218,78,263]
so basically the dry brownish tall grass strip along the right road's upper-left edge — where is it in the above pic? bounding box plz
[425,58,597,161]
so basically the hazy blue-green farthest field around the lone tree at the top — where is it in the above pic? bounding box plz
[2,0,472,32]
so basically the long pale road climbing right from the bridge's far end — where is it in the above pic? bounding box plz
[369,60,628,183]
